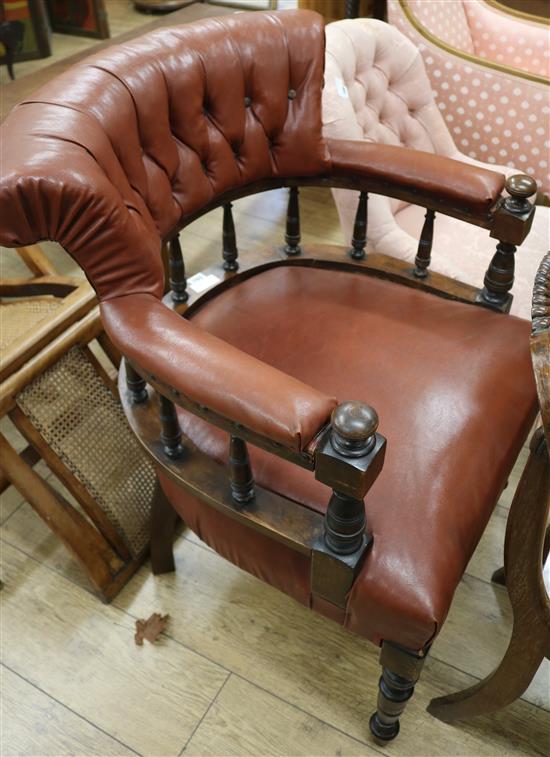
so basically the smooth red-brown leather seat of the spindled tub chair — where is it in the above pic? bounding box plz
[162,267,536,649]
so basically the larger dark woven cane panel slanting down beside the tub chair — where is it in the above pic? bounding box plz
[17,347,155,557]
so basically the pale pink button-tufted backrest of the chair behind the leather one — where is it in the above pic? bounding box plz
[323,19,457,256]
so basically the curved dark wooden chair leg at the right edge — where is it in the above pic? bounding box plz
[428,429,550,722]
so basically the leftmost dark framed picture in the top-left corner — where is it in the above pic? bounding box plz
[0,0,52,62]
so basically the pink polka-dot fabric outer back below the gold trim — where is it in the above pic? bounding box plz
[388,0,550,196]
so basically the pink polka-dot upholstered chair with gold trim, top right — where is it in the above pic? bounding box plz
[388,0,550,203]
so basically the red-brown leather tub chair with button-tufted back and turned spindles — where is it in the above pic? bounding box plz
[0,11,548,739]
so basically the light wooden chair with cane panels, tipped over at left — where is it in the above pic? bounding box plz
[0,245,166,600]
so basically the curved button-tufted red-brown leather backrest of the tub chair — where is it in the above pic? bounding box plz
[0,11,329,299]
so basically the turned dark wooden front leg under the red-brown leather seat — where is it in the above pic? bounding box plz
[369,641,432,741]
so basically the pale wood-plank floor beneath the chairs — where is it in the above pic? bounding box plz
[0,3,550,757]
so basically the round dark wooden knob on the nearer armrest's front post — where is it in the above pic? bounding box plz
[330,400,378,457]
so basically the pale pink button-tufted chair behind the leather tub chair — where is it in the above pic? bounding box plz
[323,18,550,318]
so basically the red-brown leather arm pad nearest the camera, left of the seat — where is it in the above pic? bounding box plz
[101,294,336,452]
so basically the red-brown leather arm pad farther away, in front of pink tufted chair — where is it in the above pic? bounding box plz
[327,139,506,218]
